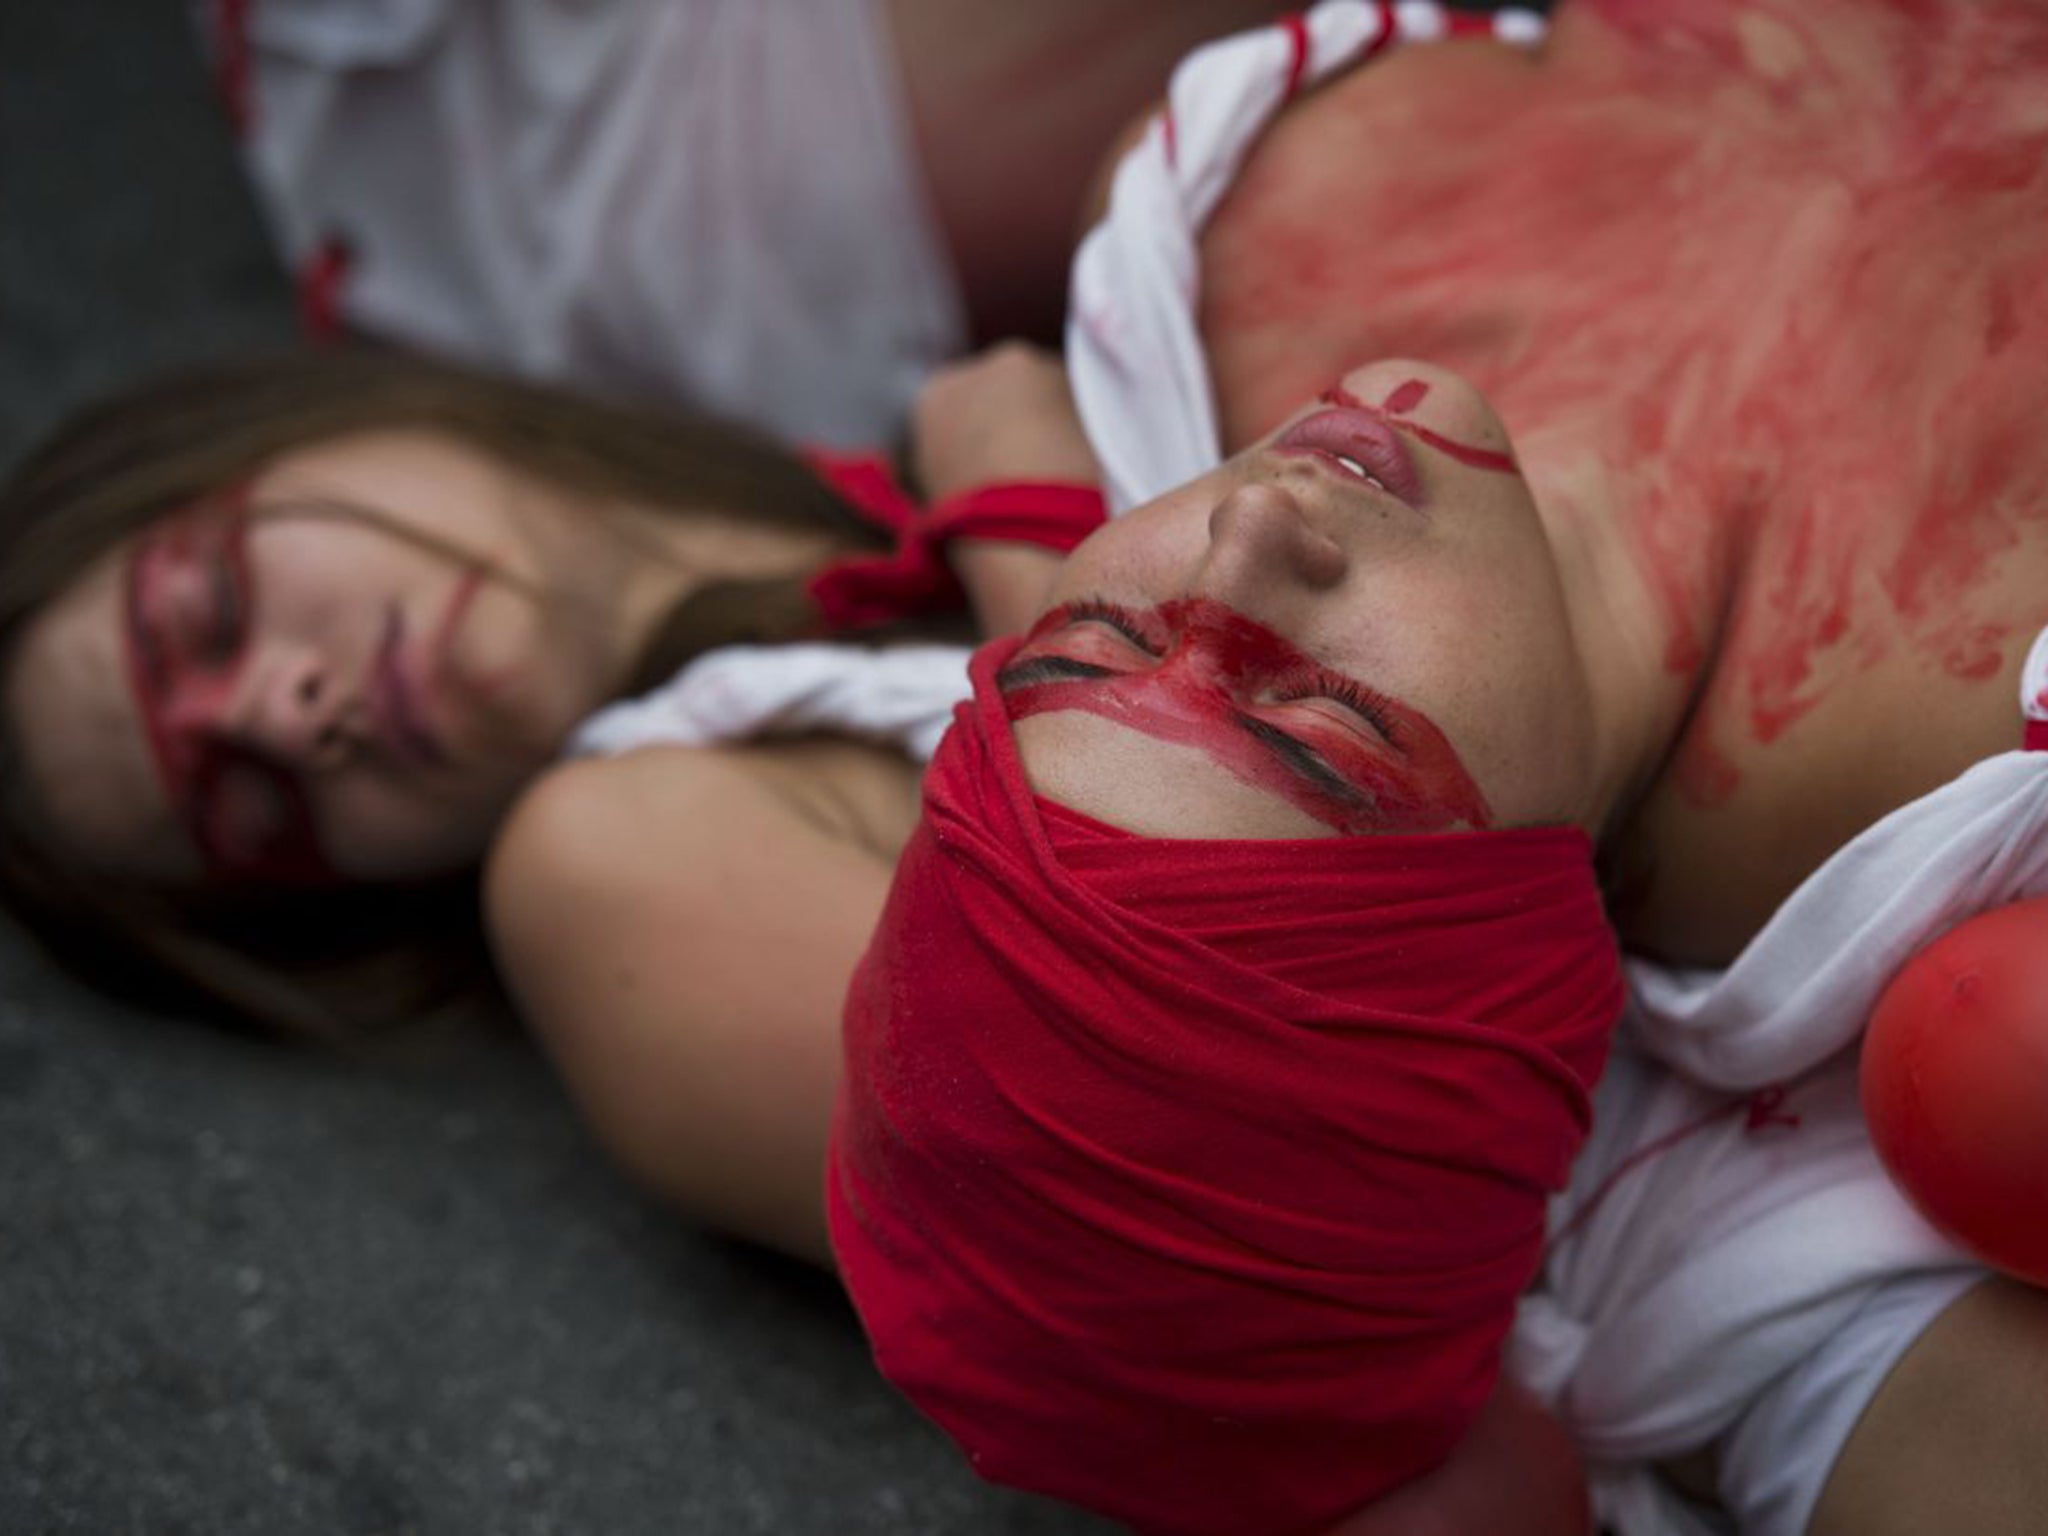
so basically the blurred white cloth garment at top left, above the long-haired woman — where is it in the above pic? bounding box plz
[205,0,967,446]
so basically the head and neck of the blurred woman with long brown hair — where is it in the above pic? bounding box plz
[0,350,1100,1036]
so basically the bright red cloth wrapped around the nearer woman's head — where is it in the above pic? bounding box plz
[827,641,1622,1536]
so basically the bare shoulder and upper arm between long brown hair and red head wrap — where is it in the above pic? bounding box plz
[485,743,915,1264]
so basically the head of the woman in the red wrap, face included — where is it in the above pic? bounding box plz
[827,362,1634,1536]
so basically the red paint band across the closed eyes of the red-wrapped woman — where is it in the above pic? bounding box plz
[1004,598,1491,834]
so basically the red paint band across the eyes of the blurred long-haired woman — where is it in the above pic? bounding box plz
[121,499,336,885]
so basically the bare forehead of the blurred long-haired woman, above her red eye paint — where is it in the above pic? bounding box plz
[0,541,199,879]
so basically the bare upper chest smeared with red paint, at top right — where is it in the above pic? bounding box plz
[1202,0,2048,803]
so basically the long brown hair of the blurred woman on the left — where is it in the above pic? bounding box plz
[0,346,897,1038]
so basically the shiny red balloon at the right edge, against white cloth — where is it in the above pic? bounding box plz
[1864,897,2048,1286]
